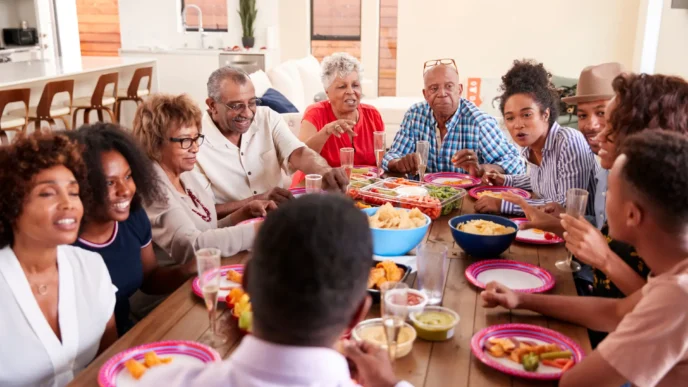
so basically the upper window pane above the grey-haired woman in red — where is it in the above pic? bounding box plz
[311,0,361,41]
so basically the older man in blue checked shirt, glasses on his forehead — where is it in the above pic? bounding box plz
[382,59,525,177]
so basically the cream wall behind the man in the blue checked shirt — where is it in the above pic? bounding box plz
[397,0,644,96]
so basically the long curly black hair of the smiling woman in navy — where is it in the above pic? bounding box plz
[67,122,166,221]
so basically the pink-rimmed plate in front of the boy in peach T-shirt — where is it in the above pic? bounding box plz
[471,324,585,380]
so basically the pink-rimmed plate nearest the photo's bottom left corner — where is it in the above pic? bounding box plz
[98,340,222,387]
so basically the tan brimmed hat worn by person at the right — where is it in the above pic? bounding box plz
[561,62,623,105]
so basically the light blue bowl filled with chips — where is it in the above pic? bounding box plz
[363,207,432,257]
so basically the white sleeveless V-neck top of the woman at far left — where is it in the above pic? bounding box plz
[0,245,117,387]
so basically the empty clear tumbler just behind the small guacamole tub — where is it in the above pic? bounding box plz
[416,242,448,305]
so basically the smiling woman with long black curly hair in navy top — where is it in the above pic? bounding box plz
[69,123,196,336]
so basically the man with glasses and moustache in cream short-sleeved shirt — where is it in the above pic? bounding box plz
[195,66,349,217]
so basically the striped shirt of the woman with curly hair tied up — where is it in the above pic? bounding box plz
[501,122,599,215]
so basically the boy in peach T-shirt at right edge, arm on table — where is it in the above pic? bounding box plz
[482,130,688,387]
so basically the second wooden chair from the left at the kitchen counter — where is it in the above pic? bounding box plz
[10,79,74,130]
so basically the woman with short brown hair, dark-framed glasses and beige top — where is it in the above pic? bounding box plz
[133,94,276,265]
